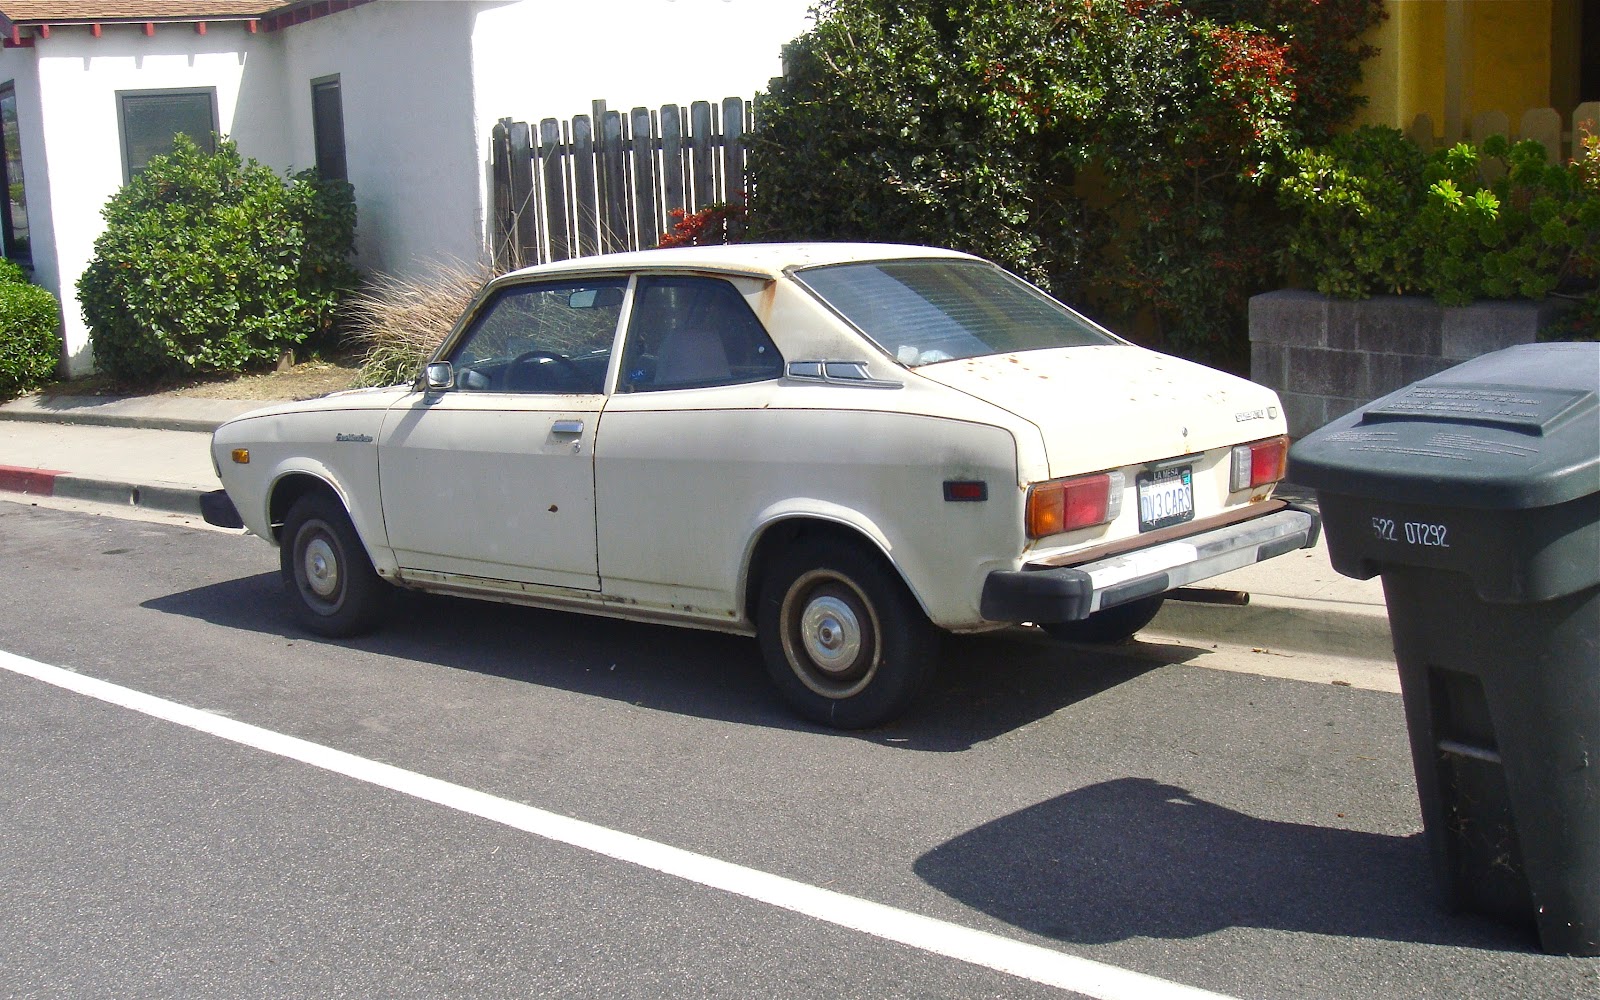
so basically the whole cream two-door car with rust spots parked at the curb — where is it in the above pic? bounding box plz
[206,245,1318,728]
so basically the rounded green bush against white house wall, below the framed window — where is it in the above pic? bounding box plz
[78,136,357,382]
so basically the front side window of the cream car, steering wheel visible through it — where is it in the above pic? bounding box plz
[446,278,627,394]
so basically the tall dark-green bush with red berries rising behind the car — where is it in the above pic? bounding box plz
[750,0,1381,365]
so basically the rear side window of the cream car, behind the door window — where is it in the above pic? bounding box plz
[619,275,784,392]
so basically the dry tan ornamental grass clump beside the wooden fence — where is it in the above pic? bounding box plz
[341,261,493,386]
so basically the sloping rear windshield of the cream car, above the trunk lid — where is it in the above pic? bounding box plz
[795,261,1117,366]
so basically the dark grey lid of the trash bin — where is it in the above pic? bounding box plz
[1290,344,1600,510]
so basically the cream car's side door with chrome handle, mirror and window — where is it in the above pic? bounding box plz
[378,278,627,590]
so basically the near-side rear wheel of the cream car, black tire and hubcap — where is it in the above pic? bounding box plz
[757,539,939,730]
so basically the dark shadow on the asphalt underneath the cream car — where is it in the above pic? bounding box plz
[142,573,1198,752]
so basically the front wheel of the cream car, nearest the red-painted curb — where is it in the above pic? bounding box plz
[278,493,390,638]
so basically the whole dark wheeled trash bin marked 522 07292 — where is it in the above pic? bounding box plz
[1290,344,1600,955]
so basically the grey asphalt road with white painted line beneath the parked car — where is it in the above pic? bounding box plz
[0,502,1600,998]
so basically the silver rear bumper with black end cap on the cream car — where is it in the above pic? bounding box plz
[979,506,1322,622]
